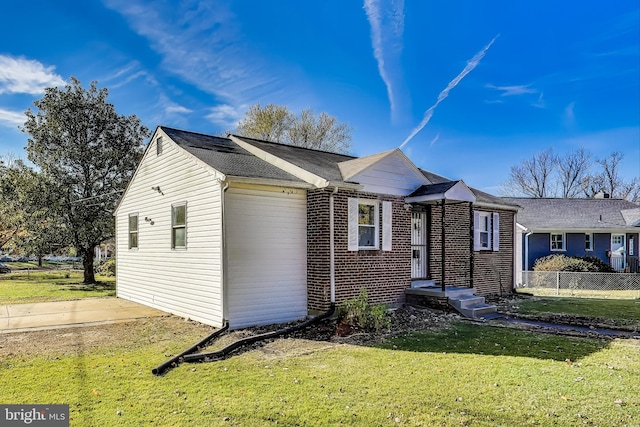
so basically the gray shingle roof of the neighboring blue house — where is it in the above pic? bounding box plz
[505,197,640,231]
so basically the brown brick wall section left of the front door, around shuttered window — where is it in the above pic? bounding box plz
[307,190,411,310]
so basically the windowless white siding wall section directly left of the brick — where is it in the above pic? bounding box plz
[225,185,307,328]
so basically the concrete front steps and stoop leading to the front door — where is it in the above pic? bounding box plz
[405,280,502,320]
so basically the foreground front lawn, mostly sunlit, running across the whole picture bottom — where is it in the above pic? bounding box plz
[0,319,640,426]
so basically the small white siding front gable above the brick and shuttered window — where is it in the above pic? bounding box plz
[350,155,425,196]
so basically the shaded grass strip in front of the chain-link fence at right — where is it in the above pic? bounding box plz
[518,297,640,321]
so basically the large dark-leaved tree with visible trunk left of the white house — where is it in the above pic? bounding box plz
[22,77,149,283]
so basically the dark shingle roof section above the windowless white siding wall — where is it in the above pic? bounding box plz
[160,126,303,182]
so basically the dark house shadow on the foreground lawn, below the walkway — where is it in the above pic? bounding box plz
[377,323,609,361]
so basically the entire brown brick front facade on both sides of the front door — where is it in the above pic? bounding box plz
[307,189,514,310]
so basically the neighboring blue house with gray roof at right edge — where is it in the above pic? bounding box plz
[505,198,640,271]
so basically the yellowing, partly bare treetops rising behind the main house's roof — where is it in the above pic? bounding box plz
[235,103,352,153]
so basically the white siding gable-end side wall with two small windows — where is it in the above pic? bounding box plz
[116,135,223,326]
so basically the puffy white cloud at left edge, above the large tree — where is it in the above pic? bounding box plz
[0,55,65,95]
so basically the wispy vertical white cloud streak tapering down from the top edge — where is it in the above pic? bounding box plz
[364,0,404,122]
